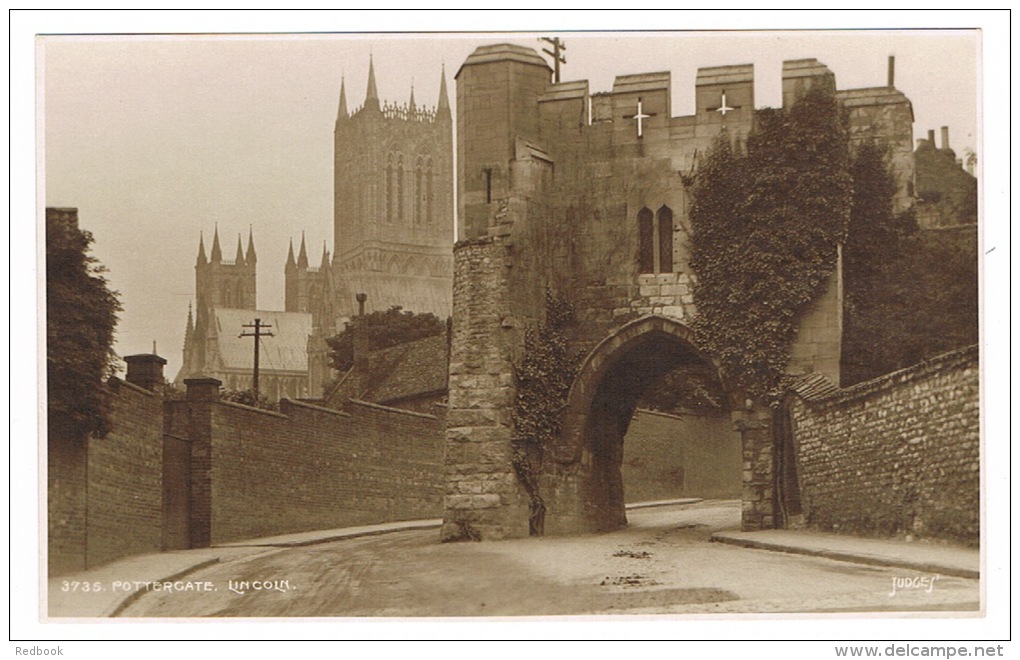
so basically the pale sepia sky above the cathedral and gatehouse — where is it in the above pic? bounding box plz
[38,24,980,378]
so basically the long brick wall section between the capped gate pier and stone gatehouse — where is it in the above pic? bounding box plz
[209,400,444,544]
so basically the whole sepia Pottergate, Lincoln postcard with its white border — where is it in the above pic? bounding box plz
[10,11,1009,657]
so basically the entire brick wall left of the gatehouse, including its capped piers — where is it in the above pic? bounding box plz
[47,371,445,575]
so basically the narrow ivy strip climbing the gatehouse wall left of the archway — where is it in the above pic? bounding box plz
[511,291,580,536]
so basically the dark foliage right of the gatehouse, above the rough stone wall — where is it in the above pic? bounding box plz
[840,145,978,386]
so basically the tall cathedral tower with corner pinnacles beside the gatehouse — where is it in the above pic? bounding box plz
[332,61,454,318]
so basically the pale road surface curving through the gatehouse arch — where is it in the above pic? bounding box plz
[120,501,979,617]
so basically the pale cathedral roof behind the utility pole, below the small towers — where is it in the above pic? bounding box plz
[212,308,312,372]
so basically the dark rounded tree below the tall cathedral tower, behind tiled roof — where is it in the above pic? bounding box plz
[326,305,446,373]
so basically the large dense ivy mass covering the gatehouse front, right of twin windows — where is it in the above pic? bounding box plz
[686,86,853,402]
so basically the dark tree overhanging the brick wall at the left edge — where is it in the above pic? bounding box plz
[46,212,120,438]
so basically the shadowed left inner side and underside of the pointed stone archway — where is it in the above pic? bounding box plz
[543,316,721,534]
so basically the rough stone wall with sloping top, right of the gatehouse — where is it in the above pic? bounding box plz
[791,346,980,545]
